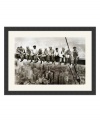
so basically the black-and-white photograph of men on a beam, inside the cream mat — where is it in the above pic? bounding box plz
[14,37,85,85]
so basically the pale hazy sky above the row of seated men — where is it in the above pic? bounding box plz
[15,37,85,58]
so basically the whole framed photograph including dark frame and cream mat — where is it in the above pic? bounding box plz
[4,27,96,95]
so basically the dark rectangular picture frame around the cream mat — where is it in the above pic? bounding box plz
[4,27,96,95]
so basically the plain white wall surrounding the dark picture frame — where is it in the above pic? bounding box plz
[0,0,100,122]
